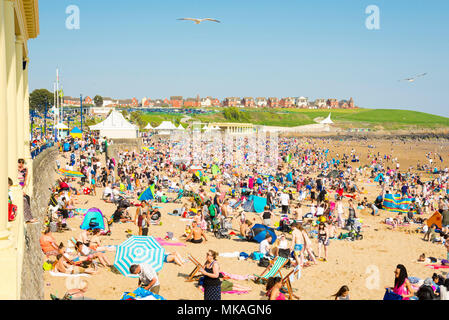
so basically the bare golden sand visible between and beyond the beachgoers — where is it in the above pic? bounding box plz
[44,140,449,300]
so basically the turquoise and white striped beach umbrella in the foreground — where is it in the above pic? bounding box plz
[114,236,165,278]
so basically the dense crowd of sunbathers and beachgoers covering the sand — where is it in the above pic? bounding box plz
[36,130,449,300]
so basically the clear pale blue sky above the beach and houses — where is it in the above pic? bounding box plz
[29,0,449,117]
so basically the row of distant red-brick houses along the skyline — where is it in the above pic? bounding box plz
[63,96,358,109]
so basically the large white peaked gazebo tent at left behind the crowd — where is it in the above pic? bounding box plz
[89,110,139,139]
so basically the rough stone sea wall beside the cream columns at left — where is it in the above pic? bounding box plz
[21,147,58,300]
